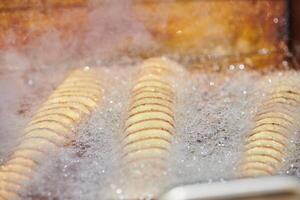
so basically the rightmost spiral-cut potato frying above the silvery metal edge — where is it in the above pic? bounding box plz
[240,86,300,177]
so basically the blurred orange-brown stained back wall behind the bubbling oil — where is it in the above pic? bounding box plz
[0,0,299,68]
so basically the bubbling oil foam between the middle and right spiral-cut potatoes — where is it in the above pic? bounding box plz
[169,72,300,185]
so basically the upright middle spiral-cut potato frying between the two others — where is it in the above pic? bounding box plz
[122,58,175,168]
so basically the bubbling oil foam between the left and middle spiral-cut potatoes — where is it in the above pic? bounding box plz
[20,67,135,199]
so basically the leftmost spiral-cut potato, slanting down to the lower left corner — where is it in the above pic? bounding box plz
[0,70,102,200]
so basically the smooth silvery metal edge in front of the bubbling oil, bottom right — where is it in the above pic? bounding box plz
[159,176,300,200]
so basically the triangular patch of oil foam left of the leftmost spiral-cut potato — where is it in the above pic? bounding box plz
[0,66,64,163]
